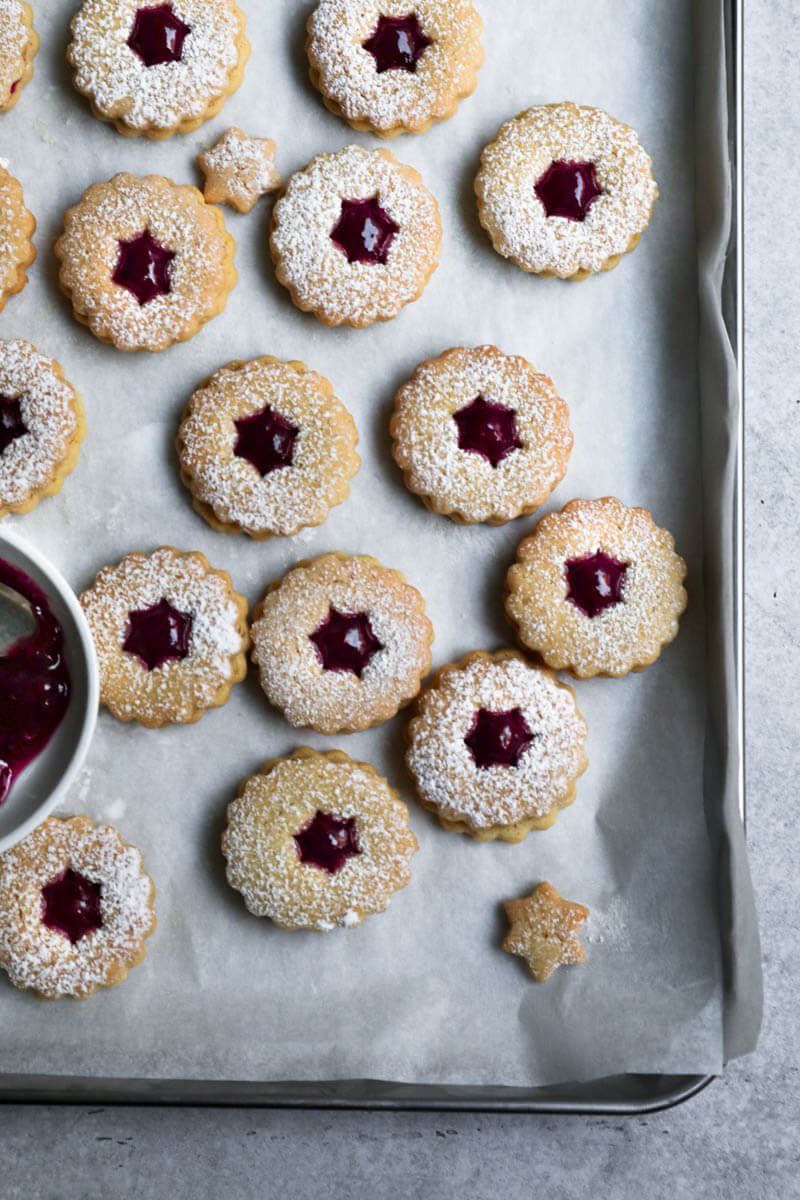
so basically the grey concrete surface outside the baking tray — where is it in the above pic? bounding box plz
[0,0,800,1200]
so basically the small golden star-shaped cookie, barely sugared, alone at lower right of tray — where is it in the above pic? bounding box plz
[503,883,589,983]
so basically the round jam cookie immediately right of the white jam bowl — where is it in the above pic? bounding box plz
[80,546,247,728]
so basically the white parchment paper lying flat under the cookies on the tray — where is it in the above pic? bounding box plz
[0,0,758,1086]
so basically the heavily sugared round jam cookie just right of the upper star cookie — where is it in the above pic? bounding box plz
[270,145,441,326]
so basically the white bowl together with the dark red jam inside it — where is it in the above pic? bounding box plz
[0,530,98,852]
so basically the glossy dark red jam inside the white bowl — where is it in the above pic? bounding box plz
[0,558,70,804]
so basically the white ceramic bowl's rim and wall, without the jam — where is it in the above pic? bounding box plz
[0,529,100,851]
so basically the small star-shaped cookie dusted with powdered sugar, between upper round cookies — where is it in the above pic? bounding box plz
[197,125,283,212]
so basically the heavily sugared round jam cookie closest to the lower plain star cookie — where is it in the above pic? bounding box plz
[405,650,587,841]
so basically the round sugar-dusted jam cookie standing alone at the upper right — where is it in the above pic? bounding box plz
[475,103,658,280]
